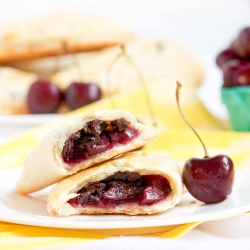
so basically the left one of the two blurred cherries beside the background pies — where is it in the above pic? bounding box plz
[27,79,63,114]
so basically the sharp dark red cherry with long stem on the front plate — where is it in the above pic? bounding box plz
[176,82,234,203]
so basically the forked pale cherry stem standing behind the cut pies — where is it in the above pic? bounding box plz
[107,45,157,126]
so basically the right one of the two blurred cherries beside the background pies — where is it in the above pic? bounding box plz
[65,82,101,109]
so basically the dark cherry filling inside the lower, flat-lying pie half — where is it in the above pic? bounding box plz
[68,171,171,209]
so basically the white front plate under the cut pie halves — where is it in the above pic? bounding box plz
[0,168,250,232]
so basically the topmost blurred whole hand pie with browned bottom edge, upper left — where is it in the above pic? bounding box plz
[0,11,134,63]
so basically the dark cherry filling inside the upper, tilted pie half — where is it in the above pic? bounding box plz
[62,118,139,164]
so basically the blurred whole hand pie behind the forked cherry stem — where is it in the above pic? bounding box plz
[51,38,204,94]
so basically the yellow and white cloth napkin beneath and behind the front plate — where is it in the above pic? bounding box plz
[0,76,250,249]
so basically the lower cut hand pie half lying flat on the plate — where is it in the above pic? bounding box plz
[47,151,183,216]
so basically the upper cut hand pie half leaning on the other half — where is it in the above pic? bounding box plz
[17,110,155,194]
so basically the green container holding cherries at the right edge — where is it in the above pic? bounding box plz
[221,86,250,131]
